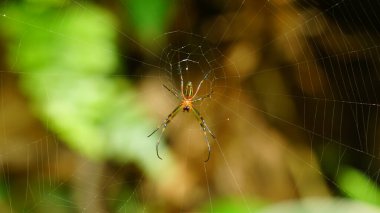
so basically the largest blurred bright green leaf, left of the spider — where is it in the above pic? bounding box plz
[1,1,170,176]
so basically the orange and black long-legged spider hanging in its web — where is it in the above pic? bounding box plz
[148,66,216,162]
